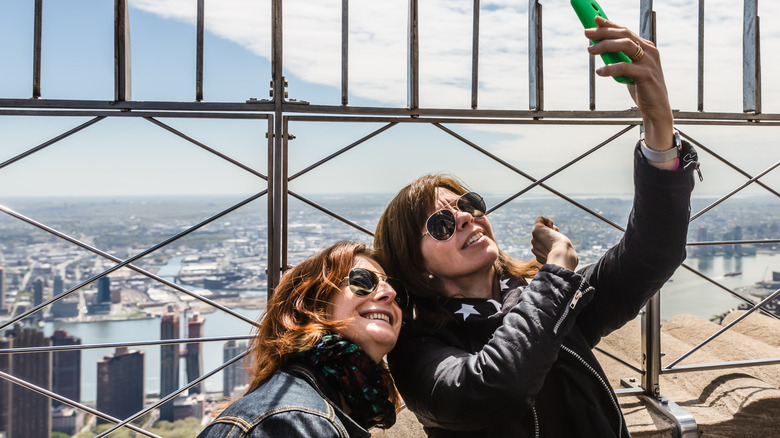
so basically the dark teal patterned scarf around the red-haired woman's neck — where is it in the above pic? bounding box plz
[297,334,395,429]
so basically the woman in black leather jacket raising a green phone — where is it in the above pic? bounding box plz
[374,18,698,437]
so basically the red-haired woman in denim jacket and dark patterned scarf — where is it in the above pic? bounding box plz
[199,242,407,438]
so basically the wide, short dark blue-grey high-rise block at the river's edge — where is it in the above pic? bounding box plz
[97,347,144,422]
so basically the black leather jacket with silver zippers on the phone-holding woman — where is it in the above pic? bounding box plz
[389,143,698,437]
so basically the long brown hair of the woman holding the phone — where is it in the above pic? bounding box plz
[374,174,539,327]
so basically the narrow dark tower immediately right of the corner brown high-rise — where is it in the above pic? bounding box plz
[51,329,81,407]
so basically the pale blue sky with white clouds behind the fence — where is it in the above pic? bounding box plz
[0,0,780,203]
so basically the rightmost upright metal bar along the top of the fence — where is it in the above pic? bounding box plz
[742,0,761,114]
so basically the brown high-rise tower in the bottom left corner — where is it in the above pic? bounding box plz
[0,324,52,438]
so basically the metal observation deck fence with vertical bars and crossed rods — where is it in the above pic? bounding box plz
[0,0,780,436]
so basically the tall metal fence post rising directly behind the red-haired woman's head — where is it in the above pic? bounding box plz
[268,0,285,298]
